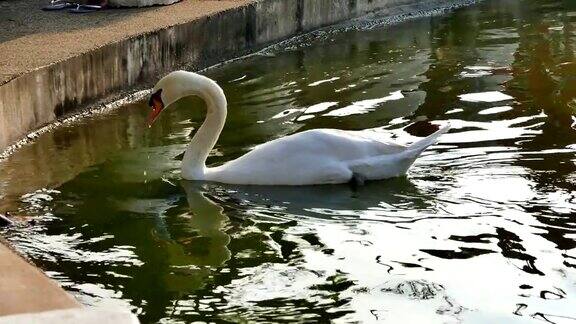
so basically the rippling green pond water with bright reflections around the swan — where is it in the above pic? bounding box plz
[0,0,576,323]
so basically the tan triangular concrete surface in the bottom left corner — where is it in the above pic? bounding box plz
[0,242,80,316]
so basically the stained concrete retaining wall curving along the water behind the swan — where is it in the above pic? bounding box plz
[0,0,466,151]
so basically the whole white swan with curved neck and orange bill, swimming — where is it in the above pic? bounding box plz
[148,71,450,185]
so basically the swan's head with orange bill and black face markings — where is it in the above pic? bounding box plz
[148,71,221,126]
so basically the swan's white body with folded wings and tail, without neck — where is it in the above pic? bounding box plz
[205,129,448,185]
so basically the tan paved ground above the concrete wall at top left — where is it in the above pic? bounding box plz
[0,0,252,85]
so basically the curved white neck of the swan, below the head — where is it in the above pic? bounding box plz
[182,82,227,180]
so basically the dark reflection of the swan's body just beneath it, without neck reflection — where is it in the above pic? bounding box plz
[181,177,434,221]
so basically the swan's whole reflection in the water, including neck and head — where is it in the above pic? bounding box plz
[156,178,433,292]
